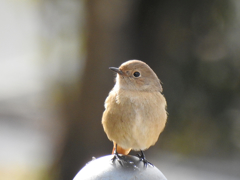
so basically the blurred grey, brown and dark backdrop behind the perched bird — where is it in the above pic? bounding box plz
[0,0,240,180]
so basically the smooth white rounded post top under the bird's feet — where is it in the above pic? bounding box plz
[73,155,167,180]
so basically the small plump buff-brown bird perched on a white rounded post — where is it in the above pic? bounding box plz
[102,60,167,165]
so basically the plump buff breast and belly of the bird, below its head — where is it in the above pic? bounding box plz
[103,90,166,150]
